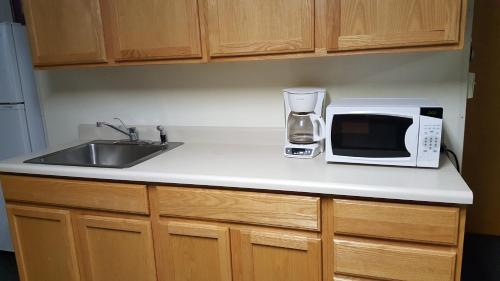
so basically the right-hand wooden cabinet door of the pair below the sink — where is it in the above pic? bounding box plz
[78,215,156,281]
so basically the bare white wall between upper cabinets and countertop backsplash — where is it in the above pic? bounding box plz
[38,48,468,160]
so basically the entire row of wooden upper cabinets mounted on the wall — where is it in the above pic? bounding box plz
[18,0,467,67]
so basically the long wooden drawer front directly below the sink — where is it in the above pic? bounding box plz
[1,176,149,214]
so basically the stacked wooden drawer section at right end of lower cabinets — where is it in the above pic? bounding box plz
[330,199,465,281]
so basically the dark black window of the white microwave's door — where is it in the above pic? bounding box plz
[331,114,413,158]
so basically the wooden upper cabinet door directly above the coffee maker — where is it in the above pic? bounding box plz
[205,0,314,56]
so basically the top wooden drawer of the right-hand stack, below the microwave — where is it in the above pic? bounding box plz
[333,200,459,245]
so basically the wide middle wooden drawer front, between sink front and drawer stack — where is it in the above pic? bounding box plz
[157,186,320,231]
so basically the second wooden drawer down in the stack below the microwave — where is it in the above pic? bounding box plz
[334,238,456,281]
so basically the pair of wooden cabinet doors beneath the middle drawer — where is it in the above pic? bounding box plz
[156,219,322,281]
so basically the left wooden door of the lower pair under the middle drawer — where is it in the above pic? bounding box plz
[158,221,231,281]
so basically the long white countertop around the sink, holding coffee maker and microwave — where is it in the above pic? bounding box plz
[0,143,473,204]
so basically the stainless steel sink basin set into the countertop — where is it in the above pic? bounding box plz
[24,141,182,168]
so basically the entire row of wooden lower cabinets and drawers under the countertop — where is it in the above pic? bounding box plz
[2,176,465,281]
